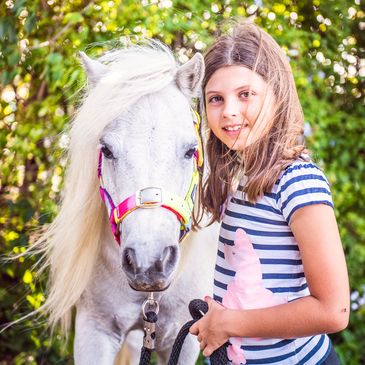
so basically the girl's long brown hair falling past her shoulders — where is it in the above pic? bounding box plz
[200,22,305,223]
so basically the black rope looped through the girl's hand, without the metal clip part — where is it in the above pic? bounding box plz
[168,299,229,365]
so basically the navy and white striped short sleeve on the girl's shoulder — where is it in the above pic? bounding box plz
[276,162,333,224]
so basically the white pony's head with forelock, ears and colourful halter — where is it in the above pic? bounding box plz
[79,45,204,291]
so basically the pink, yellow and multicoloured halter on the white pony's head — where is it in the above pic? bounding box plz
[98,111,203,245]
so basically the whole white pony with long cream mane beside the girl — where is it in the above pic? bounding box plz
[32,43,218,365]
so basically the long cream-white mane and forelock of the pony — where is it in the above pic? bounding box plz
[30,41,178,334]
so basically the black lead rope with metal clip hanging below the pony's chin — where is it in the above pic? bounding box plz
[139,293,229,365]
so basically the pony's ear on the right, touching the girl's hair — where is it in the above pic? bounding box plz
[176,53,204,98]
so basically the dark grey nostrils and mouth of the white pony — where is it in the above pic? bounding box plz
[122,246,179,291]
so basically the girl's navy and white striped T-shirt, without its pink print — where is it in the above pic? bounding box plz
[214,160,333,365]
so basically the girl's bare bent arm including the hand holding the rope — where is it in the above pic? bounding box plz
[190,204,349,356]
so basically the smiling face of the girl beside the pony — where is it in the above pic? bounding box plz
[205,66,275,151]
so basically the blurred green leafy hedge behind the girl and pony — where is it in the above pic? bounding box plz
[0,0,365,365]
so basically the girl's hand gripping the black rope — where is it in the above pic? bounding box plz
[190,297,229,357]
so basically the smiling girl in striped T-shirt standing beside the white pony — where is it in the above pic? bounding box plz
[190,23,349,364]
